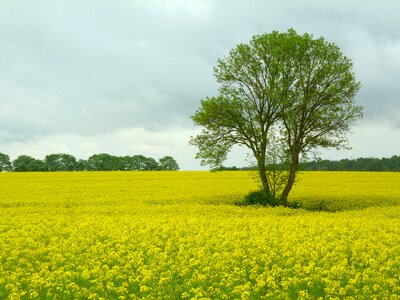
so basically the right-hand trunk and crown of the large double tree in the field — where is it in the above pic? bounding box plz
[280,30,362,200]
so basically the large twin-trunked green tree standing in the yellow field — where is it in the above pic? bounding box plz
[190,29,362,203]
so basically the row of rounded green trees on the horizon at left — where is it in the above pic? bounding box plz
[0,153,179,172]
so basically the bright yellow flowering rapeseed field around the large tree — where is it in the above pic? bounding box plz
[0,171,400,299]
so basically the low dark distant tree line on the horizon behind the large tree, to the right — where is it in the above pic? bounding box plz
[216,155,400,172]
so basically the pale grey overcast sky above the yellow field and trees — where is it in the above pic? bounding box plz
[0,0,400,170]
